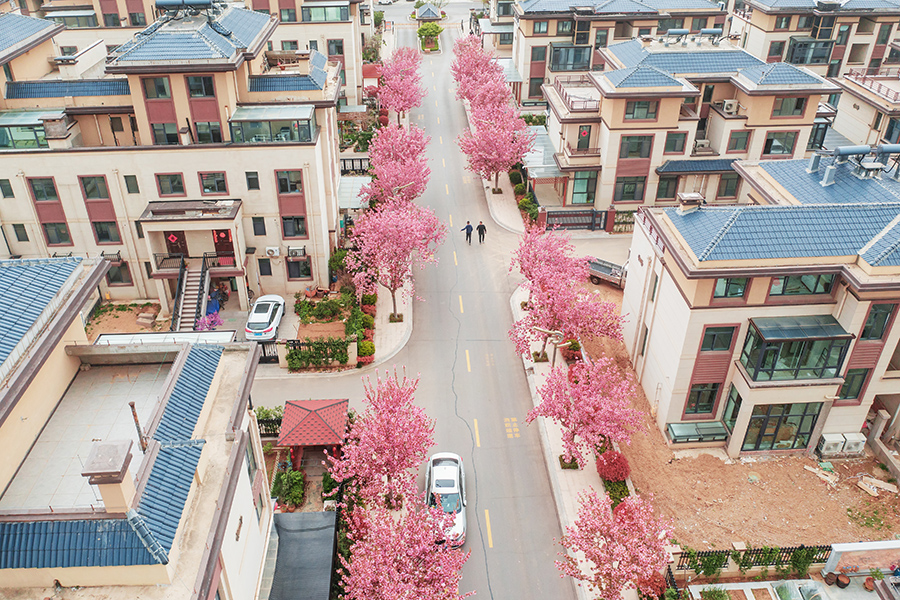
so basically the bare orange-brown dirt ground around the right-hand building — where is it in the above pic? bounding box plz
[585,284,900,550]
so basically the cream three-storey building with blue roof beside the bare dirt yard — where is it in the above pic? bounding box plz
[622,148,900,457]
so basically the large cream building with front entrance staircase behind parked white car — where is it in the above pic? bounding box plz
[0,4,348,328]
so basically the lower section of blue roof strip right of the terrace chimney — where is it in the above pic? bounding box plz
[138,440,204,553]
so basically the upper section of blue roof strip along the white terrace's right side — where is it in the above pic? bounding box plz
[153,344,224,443]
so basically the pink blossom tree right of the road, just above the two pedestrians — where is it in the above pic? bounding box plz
[458,104,534,189]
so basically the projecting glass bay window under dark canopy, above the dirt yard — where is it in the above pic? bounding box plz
[741,324,850,381]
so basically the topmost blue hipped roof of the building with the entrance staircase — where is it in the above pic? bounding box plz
[113,7,269,63]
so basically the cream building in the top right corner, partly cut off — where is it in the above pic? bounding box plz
[730,0,900,81]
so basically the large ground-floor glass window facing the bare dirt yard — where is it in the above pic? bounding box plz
[741,402,822,452]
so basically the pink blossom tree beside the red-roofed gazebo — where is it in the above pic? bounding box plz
[330,371,434,506]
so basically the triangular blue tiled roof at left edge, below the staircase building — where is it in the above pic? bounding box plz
[0,257,81,363]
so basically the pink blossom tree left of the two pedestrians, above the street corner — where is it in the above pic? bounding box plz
[345,198,447,315]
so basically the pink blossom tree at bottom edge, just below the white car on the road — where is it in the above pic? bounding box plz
[341,500,474,600]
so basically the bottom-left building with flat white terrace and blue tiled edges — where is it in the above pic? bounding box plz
[0,257,273,600]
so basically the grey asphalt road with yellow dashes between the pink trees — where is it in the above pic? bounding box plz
[253,11,575,600]
